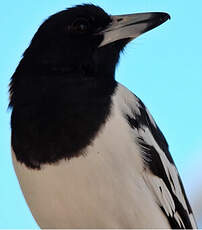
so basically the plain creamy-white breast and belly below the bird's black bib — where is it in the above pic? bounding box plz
[13,86,170,228]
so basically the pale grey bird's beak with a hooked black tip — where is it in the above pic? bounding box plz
[99,12,170,47]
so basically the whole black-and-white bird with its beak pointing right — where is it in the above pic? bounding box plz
[9,4,197,229]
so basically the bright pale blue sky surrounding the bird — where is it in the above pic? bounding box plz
[0,0,202,229]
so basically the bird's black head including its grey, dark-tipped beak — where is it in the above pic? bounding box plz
[20,4,169,78]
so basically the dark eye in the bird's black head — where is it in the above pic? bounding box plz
[68,18,90,33]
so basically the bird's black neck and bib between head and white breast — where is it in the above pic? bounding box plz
[11,67,117,169]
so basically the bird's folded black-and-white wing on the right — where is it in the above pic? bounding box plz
[118,85,197,229]
